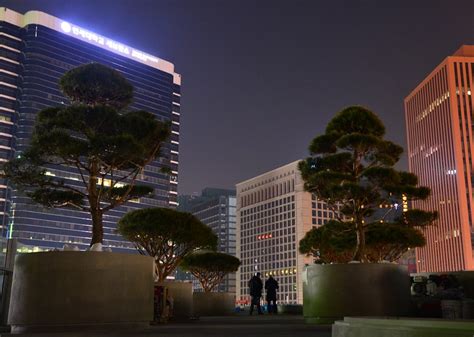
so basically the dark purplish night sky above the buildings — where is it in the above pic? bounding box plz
[0,0,474,193]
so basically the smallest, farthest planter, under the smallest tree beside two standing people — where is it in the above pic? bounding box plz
[193,293,235,317]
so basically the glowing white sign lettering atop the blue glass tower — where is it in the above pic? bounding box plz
[61,21,159,63]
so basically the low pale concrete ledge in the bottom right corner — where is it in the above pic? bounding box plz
[332,317,474,337]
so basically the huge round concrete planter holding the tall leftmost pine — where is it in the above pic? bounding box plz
[8,251,153,333]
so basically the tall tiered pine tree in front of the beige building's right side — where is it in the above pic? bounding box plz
[299,106,437,262]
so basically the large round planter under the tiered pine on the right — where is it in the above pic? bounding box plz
[303,263,411,324]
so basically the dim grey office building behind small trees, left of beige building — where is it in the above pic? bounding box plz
[179,188,236,293]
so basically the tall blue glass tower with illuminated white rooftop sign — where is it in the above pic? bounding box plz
[0,7,181,251]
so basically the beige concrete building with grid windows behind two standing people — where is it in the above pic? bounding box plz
[236,161,334,304]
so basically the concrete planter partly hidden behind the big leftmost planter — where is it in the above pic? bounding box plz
[159,281,193,320]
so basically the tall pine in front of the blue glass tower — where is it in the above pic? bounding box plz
[3,63,170,245]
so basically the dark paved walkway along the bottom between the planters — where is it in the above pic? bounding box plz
[1,315,331,337]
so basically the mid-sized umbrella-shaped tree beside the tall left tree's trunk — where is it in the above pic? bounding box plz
[118,208,217,282]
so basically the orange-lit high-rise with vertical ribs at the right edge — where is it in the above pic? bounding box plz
[405,45,474,272]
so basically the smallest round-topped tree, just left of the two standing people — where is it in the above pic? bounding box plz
[180,251,240,292]
